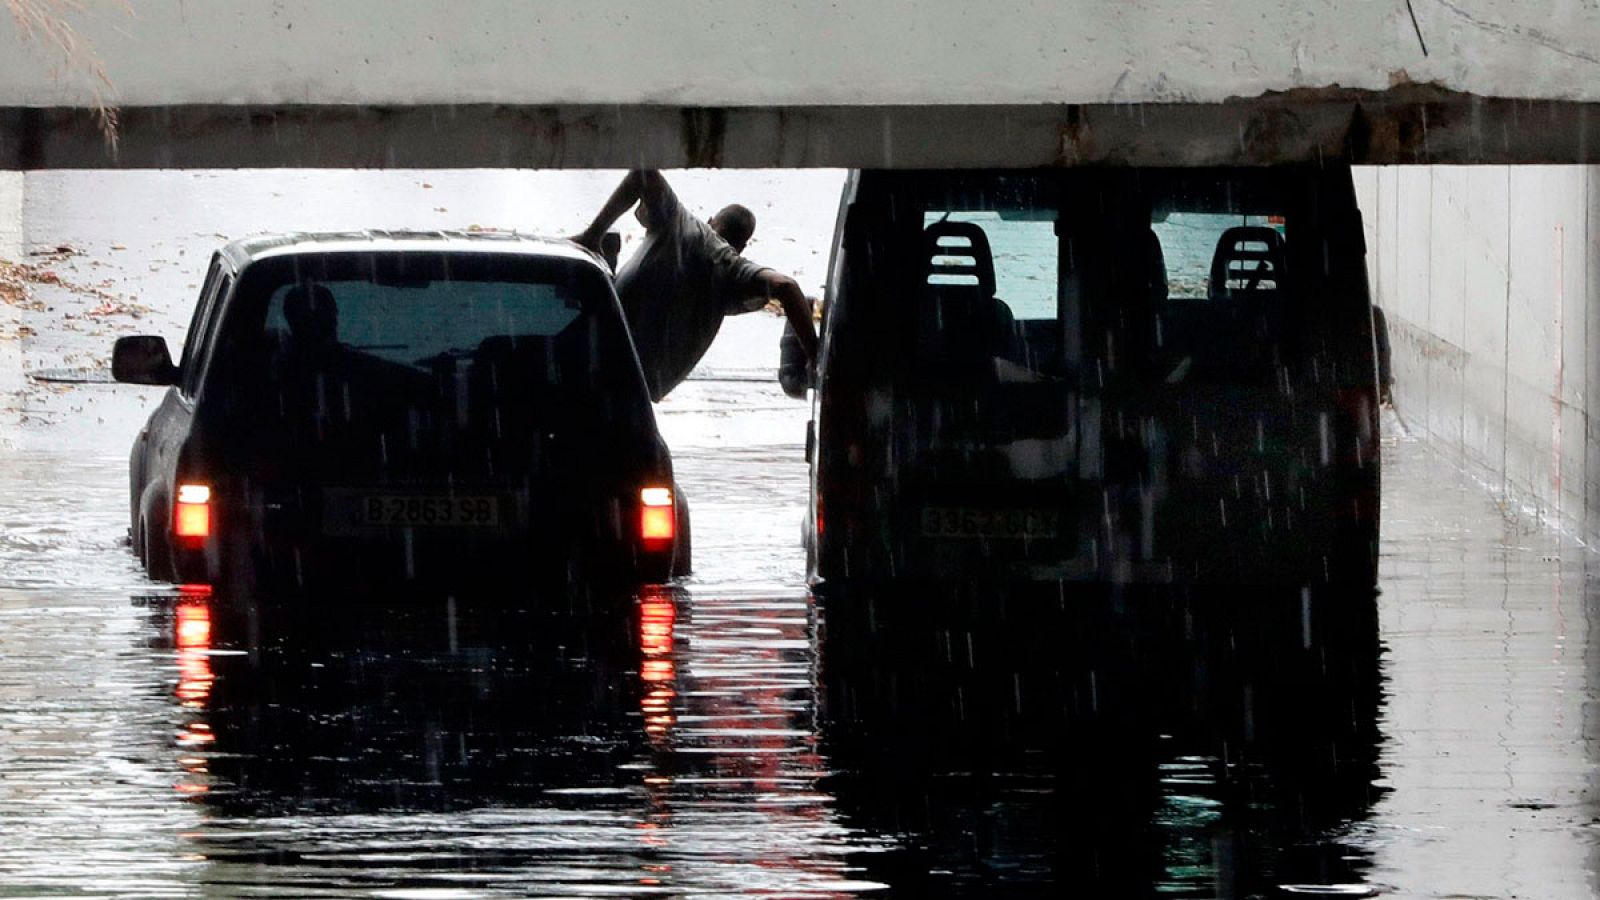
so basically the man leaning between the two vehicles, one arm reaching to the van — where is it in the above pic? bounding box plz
[573,170,816,402]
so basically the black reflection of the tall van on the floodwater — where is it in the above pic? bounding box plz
[819,589,1381,897]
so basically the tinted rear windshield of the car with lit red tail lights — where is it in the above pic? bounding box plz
[203,251,654,438]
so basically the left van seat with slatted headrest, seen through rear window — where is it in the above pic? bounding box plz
[915,219,1018,378]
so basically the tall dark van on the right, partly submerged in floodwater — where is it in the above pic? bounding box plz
[806,167,1379,588]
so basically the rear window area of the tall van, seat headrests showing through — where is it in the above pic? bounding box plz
[851,170,1337,386]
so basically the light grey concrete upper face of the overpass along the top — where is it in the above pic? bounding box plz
[0,0,1600,106]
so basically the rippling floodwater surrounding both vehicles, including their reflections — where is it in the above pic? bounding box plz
[0,408,1600,898]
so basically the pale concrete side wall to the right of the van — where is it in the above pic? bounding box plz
[1358,167,1600,541]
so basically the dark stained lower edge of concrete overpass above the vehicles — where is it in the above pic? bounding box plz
[9,92,1600,170]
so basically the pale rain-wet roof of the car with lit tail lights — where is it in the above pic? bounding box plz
[222,231,606,271]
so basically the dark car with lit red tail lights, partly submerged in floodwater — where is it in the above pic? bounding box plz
[114,232,690,591]
